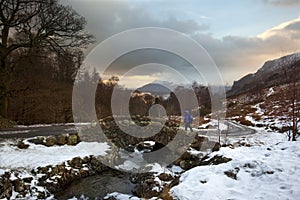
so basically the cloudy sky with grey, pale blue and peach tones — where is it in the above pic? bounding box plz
[63,0,300,87]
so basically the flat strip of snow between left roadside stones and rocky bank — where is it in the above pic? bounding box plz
[0,141,109,171]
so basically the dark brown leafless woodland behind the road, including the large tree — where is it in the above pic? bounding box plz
[0,0,210,124]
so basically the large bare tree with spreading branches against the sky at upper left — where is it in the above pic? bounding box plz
[0,0,93,117]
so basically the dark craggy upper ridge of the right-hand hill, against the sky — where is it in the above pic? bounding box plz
[227,53,300,96]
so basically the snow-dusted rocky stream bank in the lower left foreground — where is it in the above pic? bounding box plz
[0,156,112,199]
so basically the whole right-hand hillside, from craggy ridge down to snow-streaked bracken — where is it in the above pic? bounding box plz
[227,53,300,139]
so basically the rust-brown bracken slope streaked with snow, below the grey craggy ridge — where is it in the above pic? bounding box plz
[227,77,300,137]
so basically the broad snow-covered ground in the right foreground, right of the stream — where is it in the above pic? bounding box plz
[171,133,300,200]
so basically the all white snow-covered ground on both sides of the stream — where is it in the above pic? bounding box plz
[0,128,300,200]
